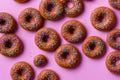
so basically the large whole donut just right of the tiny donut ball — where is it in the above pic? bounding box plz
[54,44,80,68]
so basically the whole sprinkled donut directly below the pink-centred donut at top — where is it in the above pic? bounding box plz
[61,20,86,43]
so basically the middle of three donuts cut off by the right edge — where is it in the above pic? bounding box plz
[106,29,120,50]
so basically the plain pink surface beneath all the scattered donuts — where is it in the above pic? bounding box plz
[0,0,120,80]
